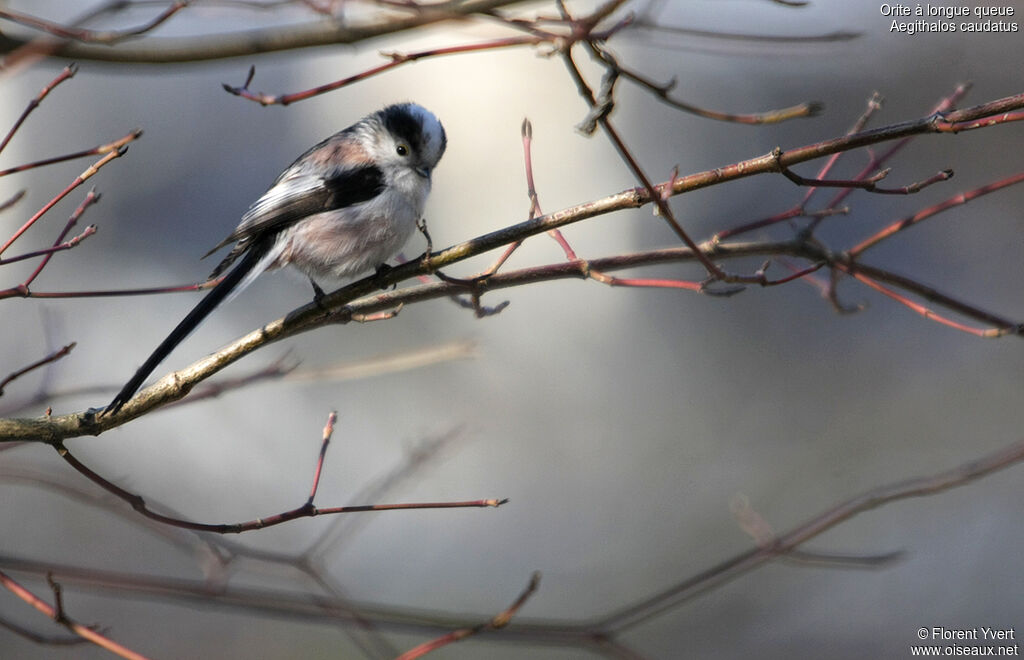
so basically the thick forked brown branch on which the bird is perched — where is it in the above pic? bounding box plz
[0,87,1024,435]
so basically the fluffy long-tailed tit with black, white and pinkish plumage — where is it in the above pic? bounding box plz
[106,103,447,413]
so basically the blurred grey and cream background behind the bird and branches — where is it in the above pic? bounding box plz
[0,0,1024,659]
